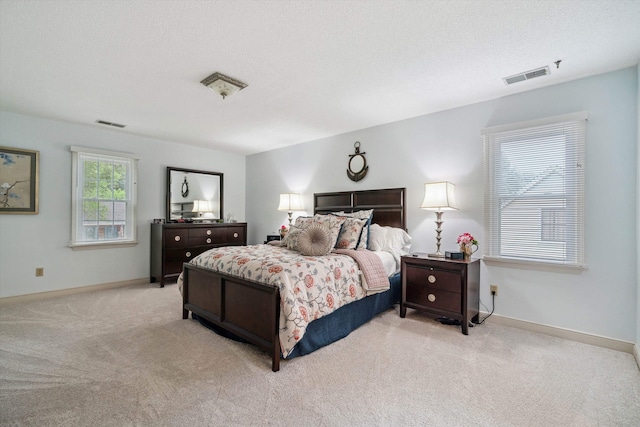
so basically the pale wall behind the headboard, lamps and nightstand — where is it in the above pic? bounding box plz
[247,67,639,342]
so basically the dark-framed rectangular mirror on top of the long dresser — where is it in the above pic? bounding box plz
[166,166,224,222]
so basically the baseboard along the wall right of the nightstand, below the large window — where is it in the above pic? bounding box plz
[480,313,640,356]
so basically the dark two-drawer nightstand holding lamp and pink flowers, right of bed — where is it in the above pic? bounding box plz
[400,254,480,335]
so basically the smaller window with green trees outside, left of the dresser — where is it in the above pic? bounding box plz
[70,147,137,248]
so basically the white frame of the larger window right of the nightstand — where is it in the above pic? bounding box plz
[481,111,588,268]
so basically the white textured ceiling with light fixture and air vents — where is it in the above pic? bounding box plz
[0,0,640,154]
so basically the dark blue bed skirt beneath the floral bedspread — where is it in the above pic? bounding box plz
[191,273,402,359]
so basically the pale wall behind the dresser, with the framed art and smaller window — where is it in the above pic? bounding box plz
[0,112,245,297]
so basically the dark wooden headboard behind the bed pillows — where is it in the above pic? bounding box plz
[313,188,407,230]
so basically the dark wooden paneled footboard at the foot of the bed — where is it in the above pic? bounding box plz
[182,264,280,372]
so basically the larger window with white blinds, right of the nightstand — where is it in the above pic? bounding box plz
[482,112,587,267]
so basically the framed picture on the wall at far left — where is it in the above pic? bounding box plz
[0,147,40,214]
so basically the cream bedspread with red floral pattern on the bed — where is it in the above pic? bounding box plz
[185,245,366,358]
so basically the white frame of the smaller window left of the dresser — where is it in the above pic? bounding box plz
[69,146,138,250]
